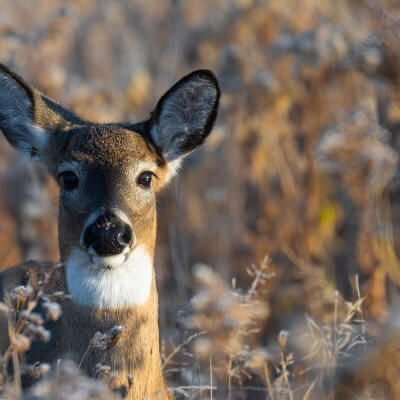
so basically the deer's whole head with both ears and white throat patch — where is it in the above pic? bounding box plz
[0,66,219,307]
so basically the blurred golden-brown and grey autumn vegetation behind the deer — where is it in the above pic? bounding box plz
[0,0,400,398]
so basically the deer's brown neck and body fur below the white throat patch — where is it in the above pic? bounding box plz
[0,263,173,400]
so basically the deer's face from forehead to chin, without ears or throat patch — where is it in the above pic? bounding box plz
[54,126,161,269]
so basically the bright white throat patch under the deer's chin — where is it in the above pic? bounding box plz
[66,247,153,308]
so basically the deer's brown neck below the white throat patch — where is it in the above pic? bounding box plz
[61,279,170,400]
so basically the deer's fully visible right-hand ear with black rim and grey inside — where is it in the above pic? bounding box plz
[149,70,220,163]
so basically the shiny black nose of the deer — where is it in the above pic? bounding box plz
[83,211,132,256]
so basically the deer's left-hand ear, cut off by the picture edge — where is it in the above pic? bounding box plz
[0,64,79,159]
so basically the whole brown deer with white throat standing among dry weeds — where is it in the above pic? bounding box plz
[0,64,220,400]
